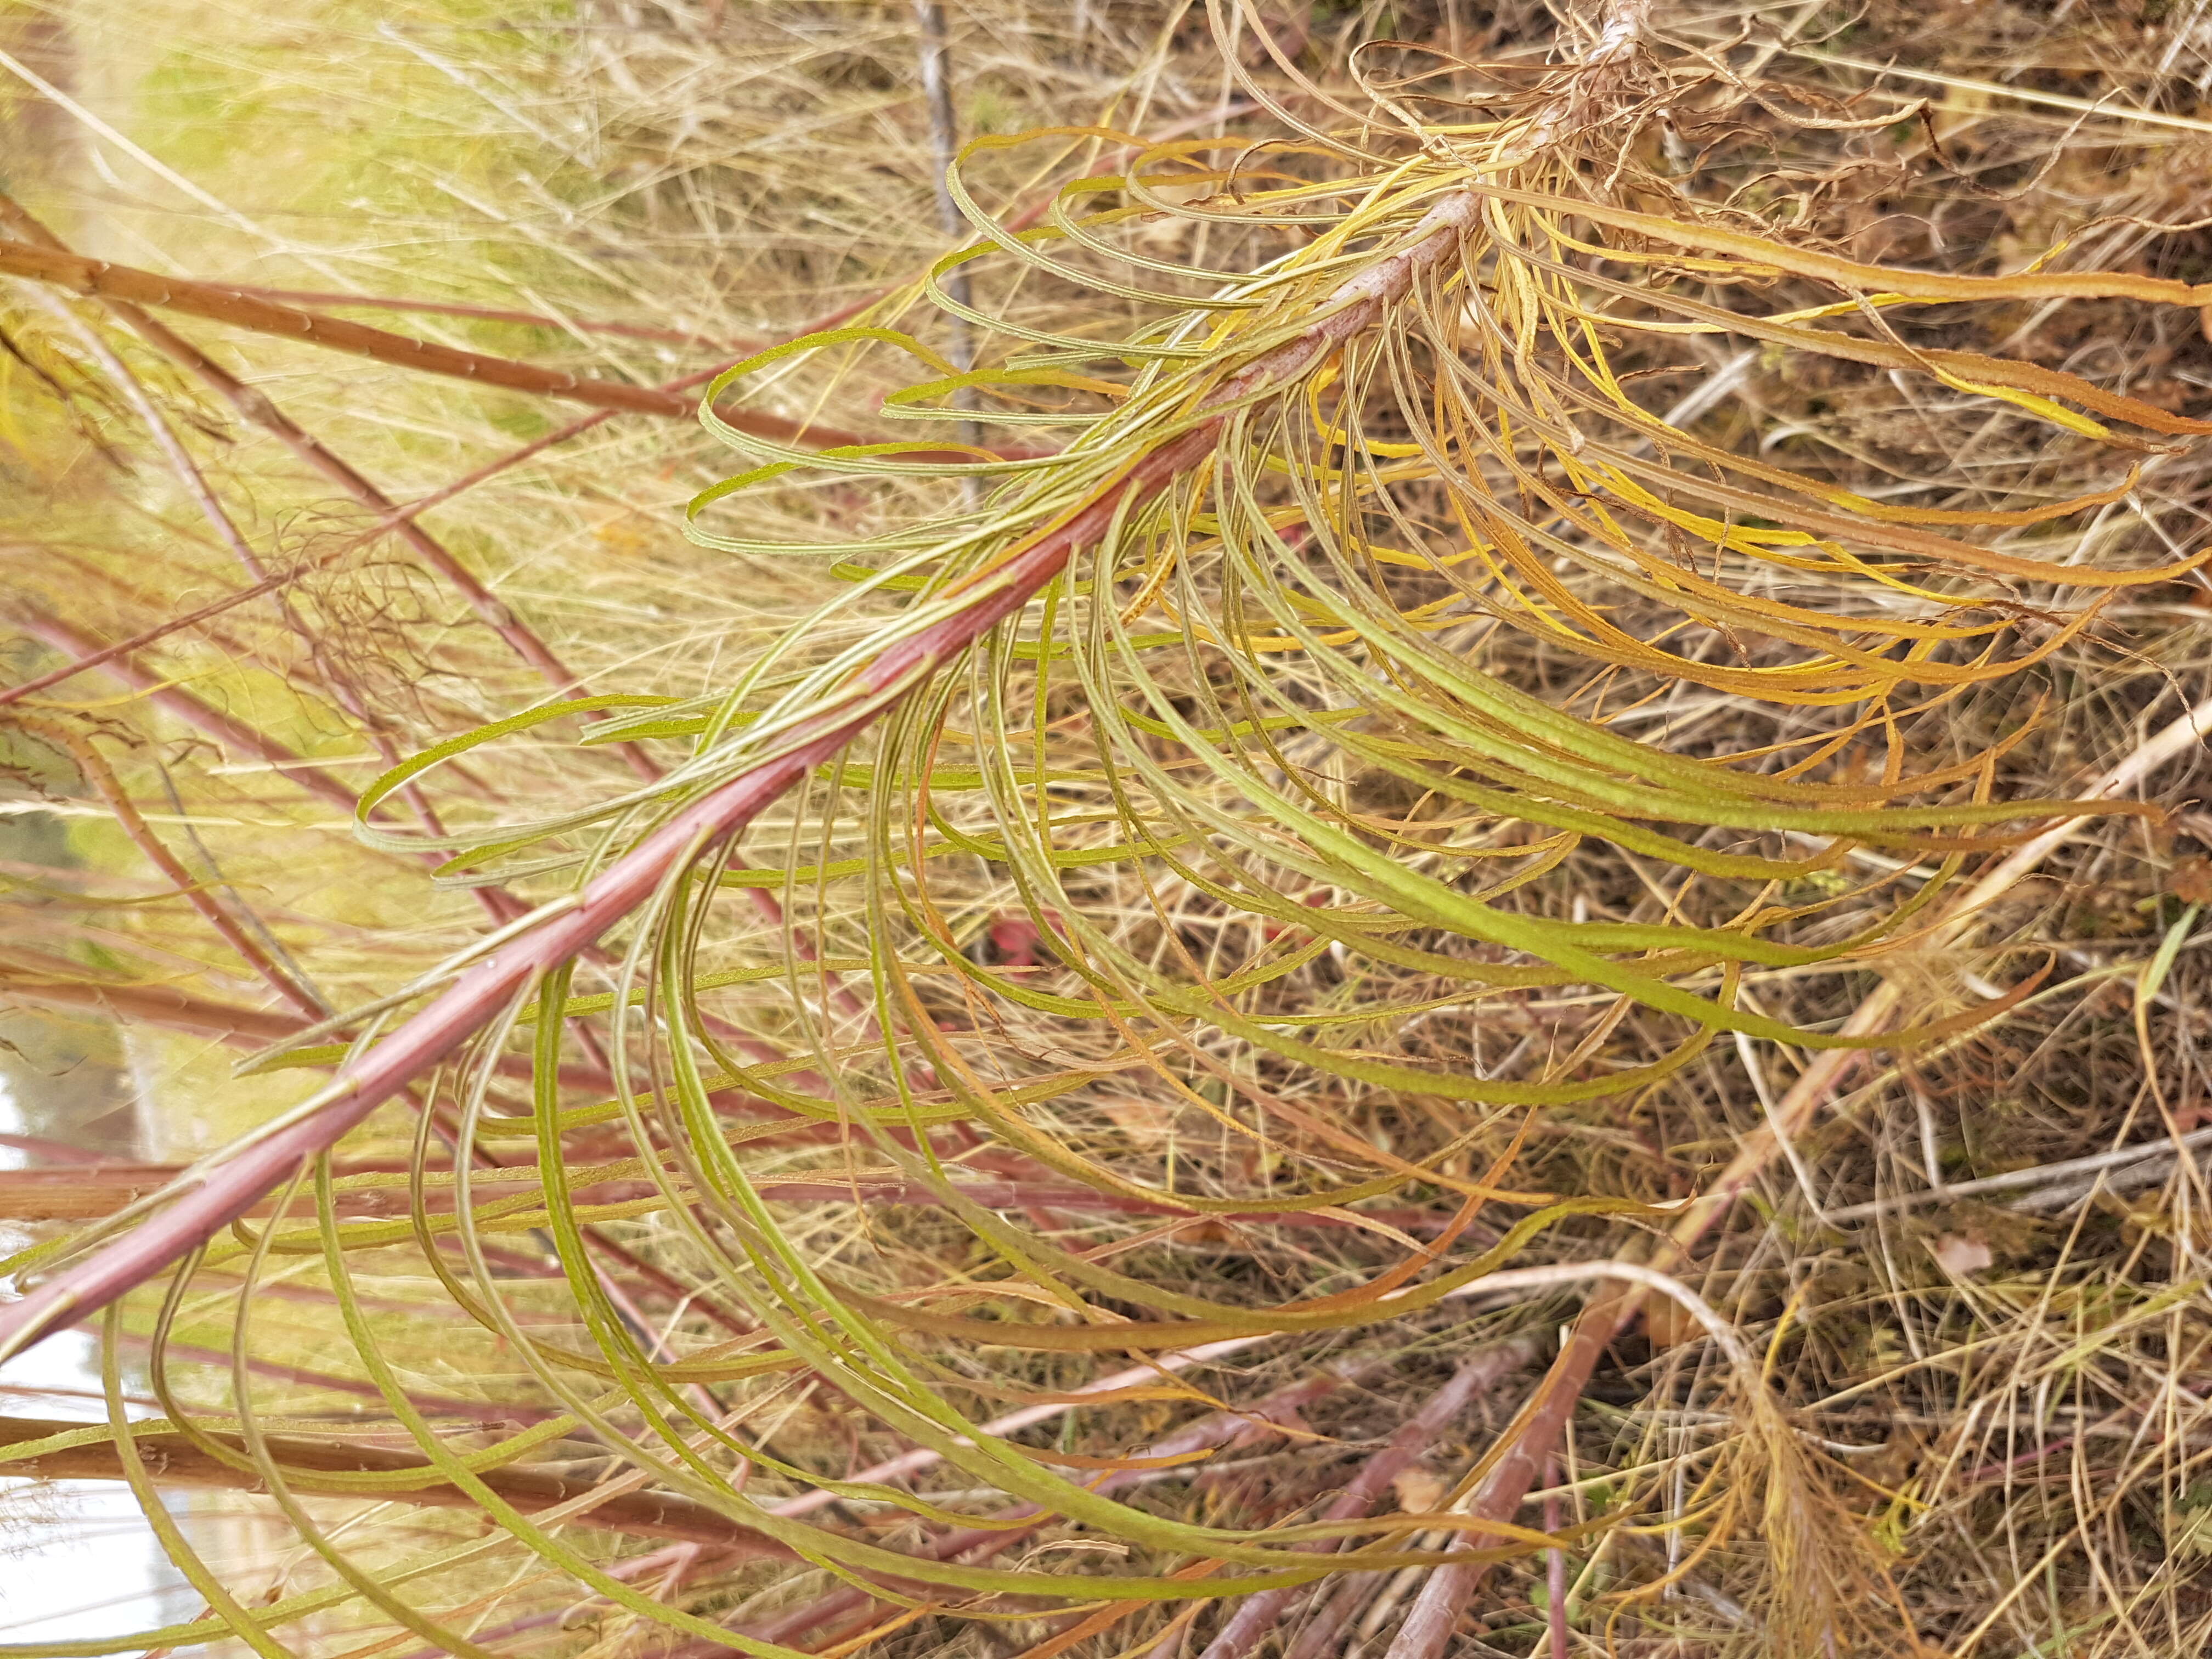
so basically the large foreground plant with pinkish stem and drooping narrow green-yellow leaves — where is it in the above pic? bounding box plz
[0,0,2212,1659]
